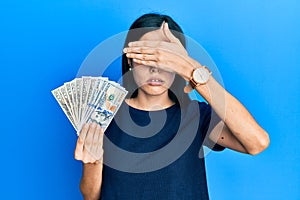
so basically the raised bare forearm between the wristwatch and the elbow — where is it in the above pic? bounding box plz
[196,77,269,154]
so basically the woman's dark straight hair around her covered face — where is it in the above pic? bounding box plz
[122,13,190,104]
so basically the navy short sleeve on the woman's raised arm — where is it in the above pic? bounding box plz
[199,102,225,151]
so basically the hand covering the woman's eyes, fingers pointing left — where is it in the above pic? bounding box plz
[124,23,196,81]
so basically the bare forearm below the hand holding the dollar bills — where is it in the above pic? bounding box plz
[80,163,103,200]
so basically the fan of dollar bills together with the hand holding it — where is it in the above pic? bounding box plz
[51,76,127,163]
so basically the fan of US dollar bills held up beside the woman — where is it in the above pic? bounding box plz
[51,76,127,134]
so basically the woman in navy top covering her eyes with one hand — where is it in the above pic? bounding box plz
[75,14,269,200]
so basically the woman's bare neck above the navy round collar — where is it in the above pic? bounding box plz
[126,92,174,111]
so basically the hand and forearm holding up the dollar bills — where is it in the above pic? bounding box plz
[75,123,104,200]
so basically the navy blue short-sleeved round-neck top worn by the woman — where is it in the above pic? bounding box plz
[100,101,224,200]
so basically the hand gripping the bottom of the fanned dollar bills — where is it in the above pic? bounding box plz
[74,122,104,164]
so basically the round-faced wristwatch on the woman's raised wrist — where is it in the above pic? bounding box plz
[190,66,211,89]
